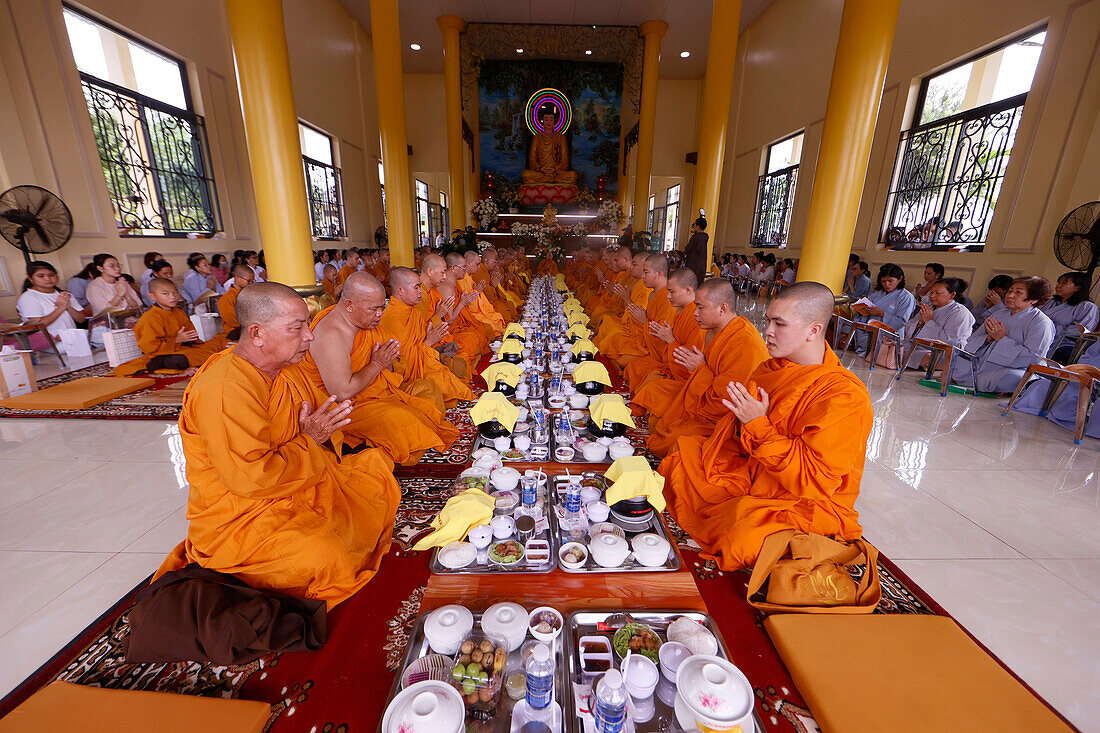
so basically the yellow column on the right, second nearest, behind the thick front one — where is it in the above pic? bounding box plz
[681,0,741,263]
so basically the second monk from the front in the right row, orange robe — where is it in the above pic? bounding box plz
[633,280,768,458]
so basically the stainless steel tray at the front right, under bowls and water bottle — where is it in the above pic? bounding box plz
[561,611,763,733]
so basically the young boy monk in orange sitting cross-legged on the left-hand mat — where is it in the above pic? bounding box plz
[114,277,226,376]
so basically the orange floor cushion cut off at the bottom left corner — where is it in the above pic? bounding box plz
[0,682,271,733]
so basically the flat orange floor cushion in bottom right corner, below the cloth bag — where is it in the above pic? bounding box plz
[763,613,1073,733]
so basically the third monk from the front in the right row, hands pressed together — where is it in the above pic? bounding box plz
[624,267,706,391]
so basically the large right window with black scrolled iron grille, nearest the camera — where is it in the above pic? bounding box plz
[880,30,1046,252]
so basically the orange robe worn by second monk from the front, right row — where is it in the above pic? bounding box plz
[631,316,768,457]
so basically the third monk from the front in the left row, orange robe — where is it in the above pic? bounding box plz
[381,267,474,407]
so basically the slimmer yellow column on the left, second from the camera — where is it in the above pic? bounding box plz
[371,0,418,267]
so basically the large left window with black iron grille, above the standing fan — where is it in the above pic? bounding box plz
[64,7,221,237]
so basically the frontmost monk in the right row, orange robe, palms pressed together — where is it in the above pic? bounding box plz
[660,282,872,570]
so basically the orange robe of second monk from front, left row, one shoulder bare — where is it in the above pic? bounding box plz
[279,306,459,464]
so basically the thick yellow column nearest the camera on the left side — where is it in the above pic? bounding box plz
[226,0,319,293]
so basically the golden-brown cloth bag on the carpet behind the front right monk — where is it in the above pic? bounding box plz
[747,529,882,613]
